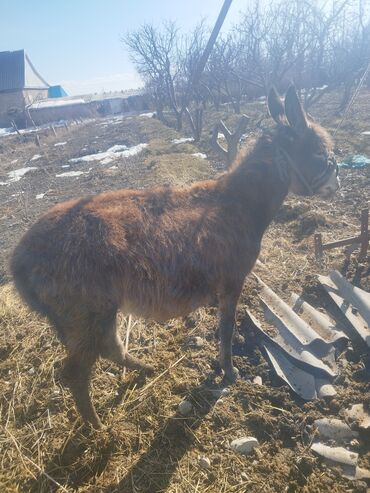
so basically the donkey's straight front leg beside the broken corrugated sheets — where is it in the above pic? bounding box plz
[219,293,239,382]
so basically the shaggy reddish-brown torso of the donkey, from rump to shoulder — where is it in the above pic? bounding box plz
[11,182,251,321]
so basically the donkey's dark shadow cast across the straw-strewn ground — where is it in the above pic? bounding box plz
[24,373,222,493]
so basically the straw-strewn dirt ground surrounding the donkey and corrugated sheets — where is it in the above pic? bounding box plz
[0,91,370,493]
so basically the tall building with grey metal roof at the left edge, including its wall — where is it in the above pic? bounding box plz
[0,50,49,127]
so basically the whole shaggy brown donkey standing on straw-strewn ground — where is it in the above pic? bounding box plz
[11,87,338,427]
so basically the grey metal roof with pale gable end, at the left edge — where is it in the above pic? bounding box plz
[0,50,49,92]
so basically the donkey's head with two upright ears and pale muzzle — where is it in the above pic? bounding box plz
[268,86,339,197]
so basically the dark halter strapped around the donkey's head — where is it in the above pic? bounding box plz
[275,147,338,195]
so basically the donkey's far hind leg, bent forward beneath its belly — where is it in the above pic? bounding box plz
[99,313,154,373]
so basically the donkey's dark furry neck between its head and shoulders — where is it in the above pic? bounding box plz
[223,135,289,236]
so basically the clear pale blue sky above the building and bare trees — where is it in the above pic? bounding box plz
[0,0,248,95]
